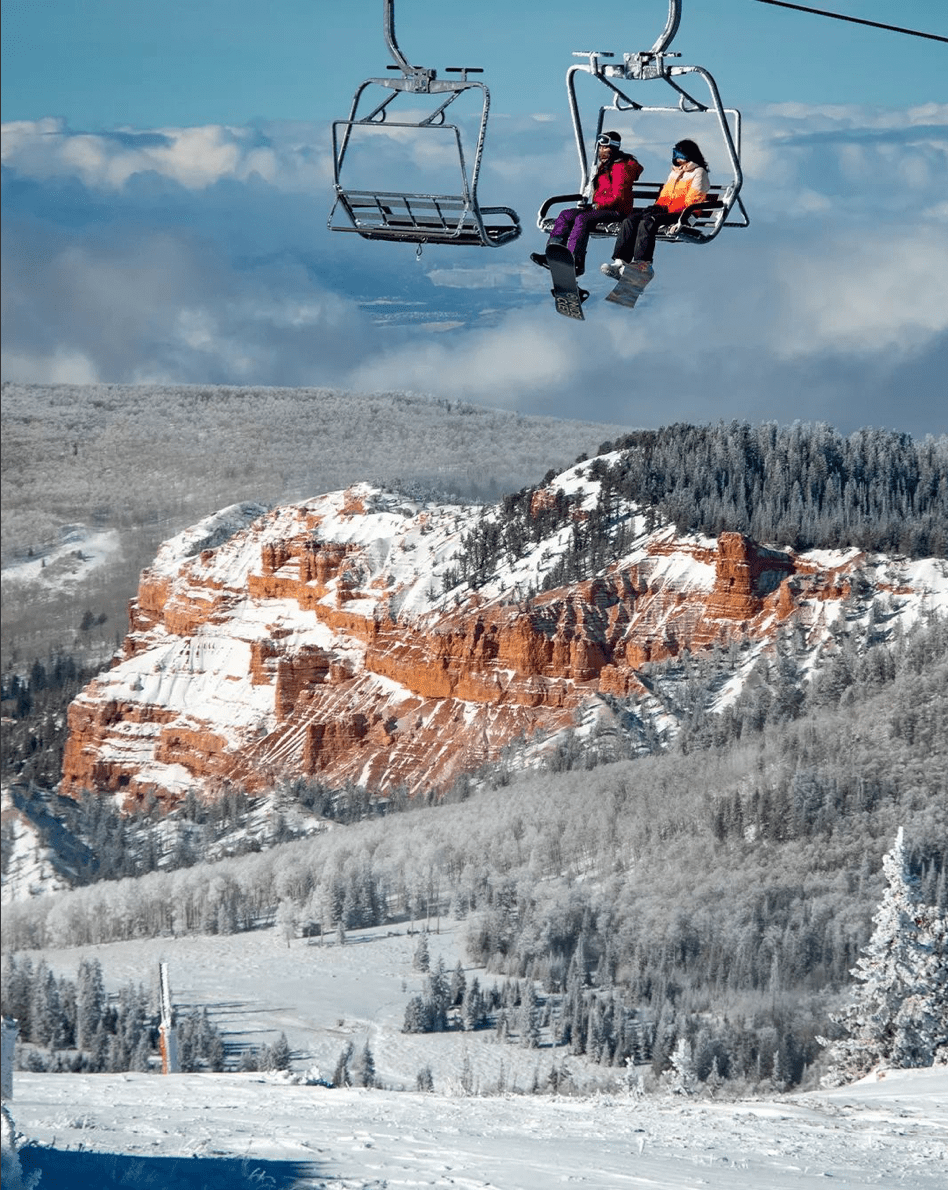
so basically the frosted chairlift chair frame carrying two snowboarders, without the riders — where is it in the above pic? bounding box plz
[536,0,749,317]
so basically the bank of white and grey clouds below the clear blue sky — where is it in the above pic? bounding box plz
[4,105,948,428]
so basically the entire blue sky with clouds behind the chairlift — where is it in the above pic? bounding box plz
[2,0,948,434]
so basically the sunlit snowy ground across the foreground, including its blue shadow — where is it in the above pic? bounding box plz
[12,1067,948,1190]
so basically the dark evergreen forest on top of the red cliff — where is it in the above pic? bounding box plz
[457,421,948,587]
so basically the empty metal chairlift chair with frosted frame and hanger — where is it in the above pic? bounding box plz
[328,0,521,255]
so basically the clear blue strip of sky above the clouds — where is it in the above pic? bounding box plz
[1,0,948,123]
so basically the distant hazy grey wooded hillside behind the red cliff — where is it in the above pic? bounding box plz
[0,382,623,678]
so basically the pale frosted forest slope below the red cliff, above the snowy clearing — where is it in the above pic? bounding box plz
[4,619,948,1085]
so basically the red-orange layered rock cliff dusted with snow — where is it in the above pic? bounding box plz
[63,465,948,806]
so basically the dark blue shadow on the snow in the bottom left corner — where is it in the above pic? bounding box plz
[19,1145,316,1190]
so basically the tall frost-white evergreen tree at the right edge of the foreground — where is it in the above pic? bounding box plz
[820,827,948,1085]
